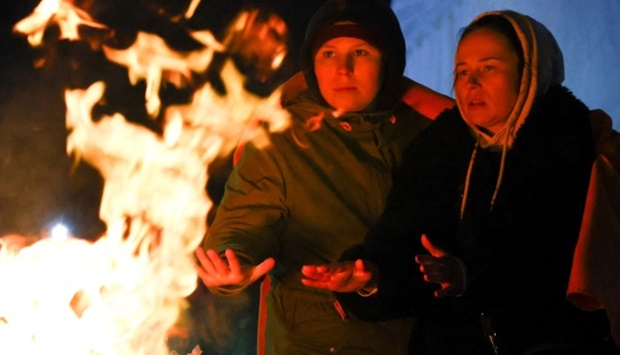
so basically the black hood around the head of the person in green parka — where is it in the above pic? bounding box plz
[300,0,406,109]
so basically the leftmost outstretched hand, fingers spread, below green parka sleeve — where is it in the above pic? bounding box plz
[196,247,275,287]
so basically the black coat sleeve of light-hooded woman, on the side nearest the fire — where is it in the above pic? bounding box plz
[337,117,462,321]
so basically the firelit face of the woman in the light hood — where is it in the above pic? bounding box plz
[454,28,520,134]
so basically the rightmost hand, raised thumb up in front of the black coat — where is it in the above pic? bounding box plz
[415,235,467,297]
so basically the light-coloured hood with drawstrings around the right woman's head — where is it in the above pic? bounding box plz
[461,10,564,148]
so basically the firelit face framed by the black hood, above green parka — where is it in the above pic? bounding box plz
[314,37,381,111]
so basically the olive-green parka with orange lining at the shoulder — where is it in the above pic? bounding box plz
[204,76,452,353]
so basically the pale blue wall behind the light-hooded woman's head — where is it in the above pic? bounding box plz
[392,0,620,130]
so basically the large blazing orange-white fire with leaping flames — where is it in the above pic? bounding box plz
[0,0,289,354]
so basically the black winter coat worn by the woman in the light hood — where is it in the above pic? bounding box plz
[360,87,607,354]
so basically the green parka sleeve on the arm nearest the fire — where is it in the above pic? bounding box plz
[203,144,288,294]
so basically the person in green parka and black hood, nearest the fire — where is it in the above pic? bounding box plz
[197,0,453,354]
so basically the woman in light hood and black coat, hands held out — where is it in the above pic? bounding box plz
[303,11,617,354]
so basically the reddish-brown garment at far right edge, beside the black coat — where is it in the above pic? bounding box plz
[567,110,620,344]
